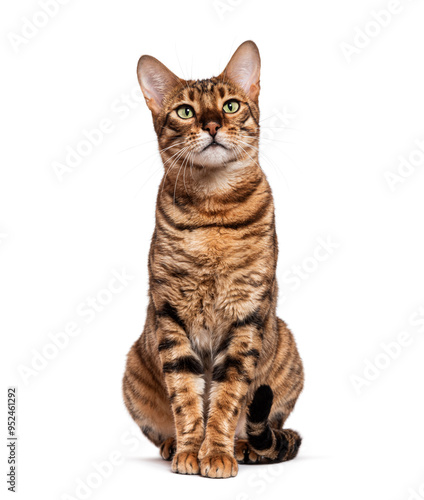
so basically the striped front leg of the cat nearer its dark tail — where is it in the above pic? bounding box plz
[199,321,261,477]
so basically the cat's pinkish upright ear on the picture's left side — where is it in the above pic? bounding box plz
[137,56,183,115]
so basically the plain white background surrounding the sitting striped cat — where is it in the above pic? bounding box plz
[0,0,424,500]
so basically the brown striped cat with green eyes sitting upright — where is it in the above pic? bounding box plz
[123,41,304,478]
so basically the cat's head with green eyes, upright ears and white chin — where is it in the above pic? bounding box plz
[137,41,260,169]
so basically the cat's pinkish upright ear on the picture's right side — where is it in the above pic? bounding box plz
[221,40,261,101]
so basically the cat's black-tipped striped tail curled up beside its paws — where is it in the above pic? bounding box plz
[246,385,302,462]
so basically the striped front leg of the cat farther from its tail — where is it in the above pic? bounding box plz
[157,307,205,474]
